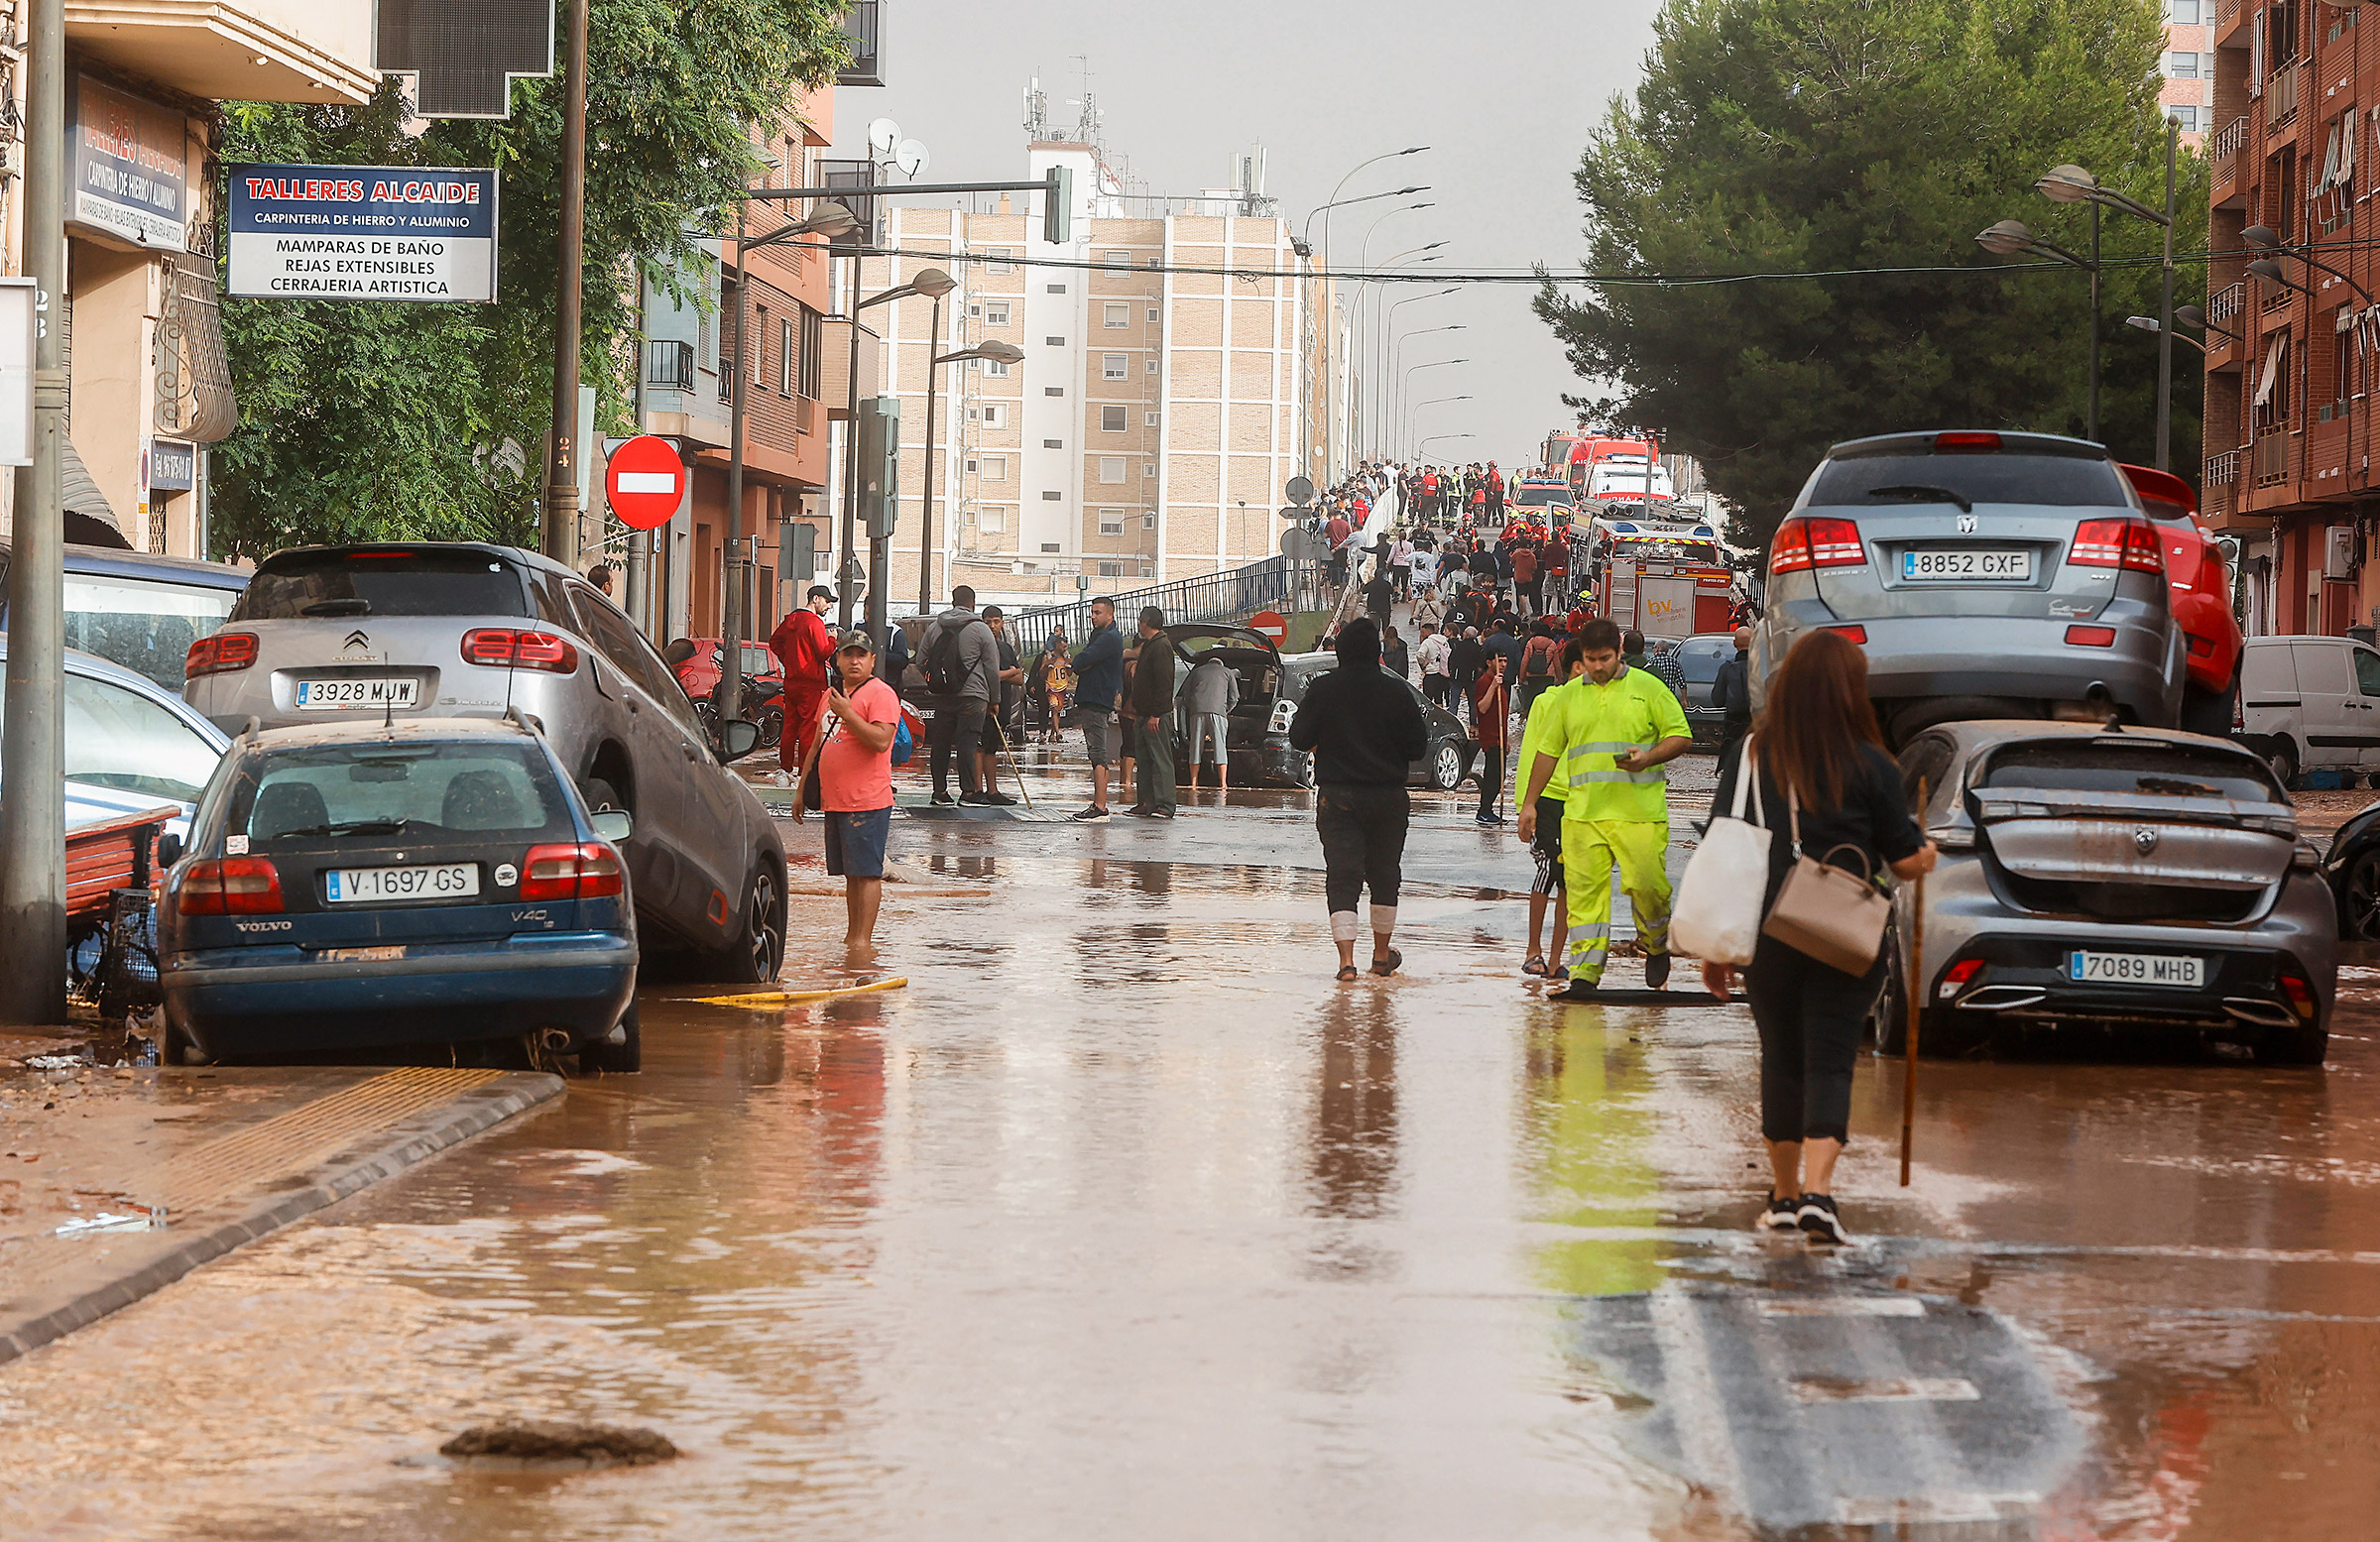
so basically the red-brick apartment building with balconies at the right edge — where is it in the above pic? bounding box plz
[2202,0,2380,633]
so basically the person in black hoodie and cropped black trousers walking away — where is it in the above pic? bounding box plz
[1290,617,1430,981]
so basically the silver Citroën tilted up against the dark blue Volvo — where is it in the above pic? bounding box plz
[183,542,785,981]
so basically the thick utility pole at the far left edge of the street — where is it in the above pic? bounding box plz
[0,0,66,1025]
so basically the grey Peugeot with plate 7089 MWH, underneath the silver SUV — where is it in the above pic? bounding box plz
[1873,721,2339,1066]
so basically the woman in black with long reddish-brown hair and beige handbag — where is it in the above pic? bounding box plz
[1702,631,1935,1245]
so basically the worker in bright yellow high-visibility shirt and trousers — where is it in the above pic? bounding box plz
[1521,617,1695,1002]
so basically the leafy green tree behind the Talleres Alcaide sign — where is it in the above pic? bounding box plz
[212,0,845,554]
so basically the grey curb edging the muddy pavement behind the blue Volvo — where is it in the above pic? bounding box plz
[0,1071,564,1365]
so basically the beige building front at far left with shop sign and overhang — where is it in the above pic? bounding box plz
[0,0,379,557]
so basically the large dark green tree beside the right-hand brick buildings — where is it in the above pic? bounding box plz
[1537,0,2206,545]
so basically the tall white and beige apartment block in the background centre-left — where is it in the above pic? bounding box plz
[862,141,1331,612]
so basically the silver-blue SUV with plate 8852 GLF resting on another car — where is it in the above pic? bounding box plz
[1751,430,2185,745]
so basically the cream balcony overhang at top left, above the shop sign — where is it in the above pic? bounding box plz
[66,0,381,107]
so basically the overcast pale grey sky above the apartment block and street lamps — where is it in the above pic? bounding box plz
[835,0,1656,466]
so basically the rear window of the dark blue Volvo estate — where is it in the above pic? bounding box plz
[224,740,571,845]
